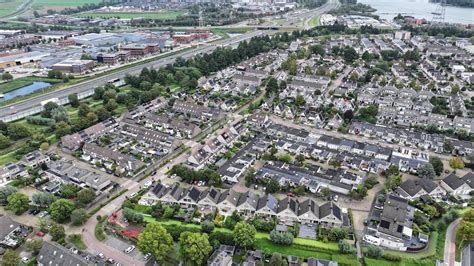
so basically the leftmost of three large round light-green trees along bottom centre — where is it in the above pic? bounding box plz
[137,223,173,262]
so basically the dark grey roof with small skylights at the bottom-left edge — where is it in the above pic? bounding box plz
[36,241,92,266]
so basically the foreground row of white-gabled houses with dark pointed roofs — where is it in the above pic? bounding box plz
[139,183,346,227]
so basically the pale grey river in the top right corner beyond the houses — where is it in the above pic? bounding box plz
[357,0,474,24]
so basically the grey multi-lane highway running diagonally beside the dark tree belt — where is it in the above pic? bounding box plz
[0,0,339,122]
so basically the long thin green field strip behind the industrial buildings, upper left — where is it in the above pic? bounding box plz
[78,11,185,20]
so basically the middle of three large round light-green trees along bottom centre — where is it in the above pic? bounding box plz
[179,232,212,265]
